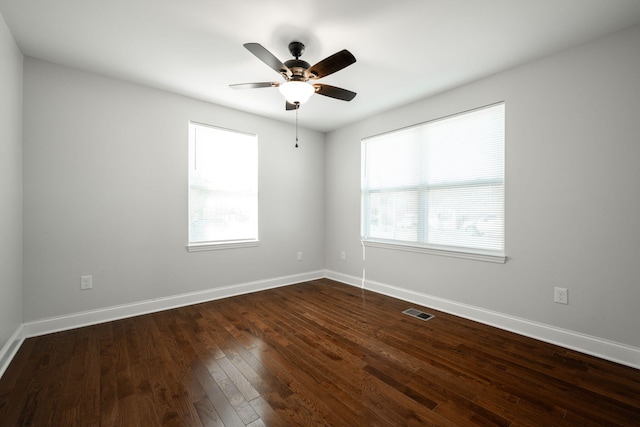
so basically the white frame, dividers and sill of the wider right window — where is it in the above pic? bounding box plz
[360,101,507,263]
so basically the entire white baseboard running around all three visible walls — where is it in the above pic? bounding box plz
[0,270,640,377]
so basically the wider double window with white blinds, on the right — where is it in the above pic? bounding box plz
[362,103,505,262]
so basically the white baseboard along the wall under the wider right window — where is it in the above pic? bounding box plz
[325,271,640,369]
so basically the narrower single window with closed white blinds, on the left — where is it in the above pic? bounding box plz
[189,123,258,250]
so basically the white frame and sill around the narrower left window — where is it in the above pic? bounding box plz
[186,121,260,252]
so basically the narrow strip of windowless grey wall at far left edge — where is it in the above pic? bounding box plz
[0,11,22,356]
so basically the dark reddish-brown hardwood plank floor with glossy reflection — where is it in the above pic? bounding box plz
[0,279,640,427]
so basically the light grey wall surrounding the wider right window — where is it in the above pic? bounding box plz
[325,27,640,352]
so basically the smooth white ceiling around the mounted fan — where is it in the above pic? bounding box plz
[0,0,640,131]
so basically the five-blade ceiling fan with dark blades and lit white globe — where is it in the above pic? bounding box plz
[230,41,356,110]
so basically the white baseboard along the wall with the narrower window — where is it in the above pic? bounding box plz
[23,270,324,338]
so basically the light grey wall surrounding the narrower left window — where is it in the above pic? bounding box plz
[24,58,324,322]
